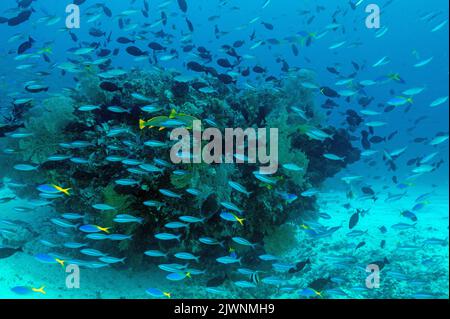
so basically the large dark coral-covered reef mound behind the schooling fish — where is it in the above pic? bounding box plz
[0,70,359,273]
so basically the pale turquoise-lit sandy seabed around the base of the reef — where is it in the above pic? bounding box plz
[0,180,449,298]
